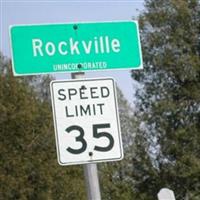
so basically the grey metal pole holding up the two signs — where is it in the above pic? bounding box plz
[71,72,101,200]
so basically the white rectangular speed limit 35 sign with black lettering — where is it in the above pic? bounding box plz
[51,78,123,165]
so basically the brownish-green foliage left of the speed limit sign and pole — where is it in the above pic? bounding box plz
[0,56,86,200]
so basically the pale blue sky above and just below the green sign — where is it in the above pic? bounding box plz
[0,0,144,105]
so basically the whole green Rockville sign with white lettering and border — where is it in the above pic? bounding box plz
[10,21,142,76]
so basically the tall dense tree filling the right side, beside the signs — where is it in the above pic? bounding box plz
[132,0,200,199]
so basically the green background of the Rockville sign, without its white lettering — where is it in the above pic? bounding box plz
[10,21,142,76]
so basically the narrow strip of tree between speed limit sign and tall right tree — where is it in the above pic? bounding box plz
[99,89,136,200]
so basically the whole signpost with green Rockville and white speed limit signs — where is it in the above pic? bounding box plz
[10,21,143,200]
